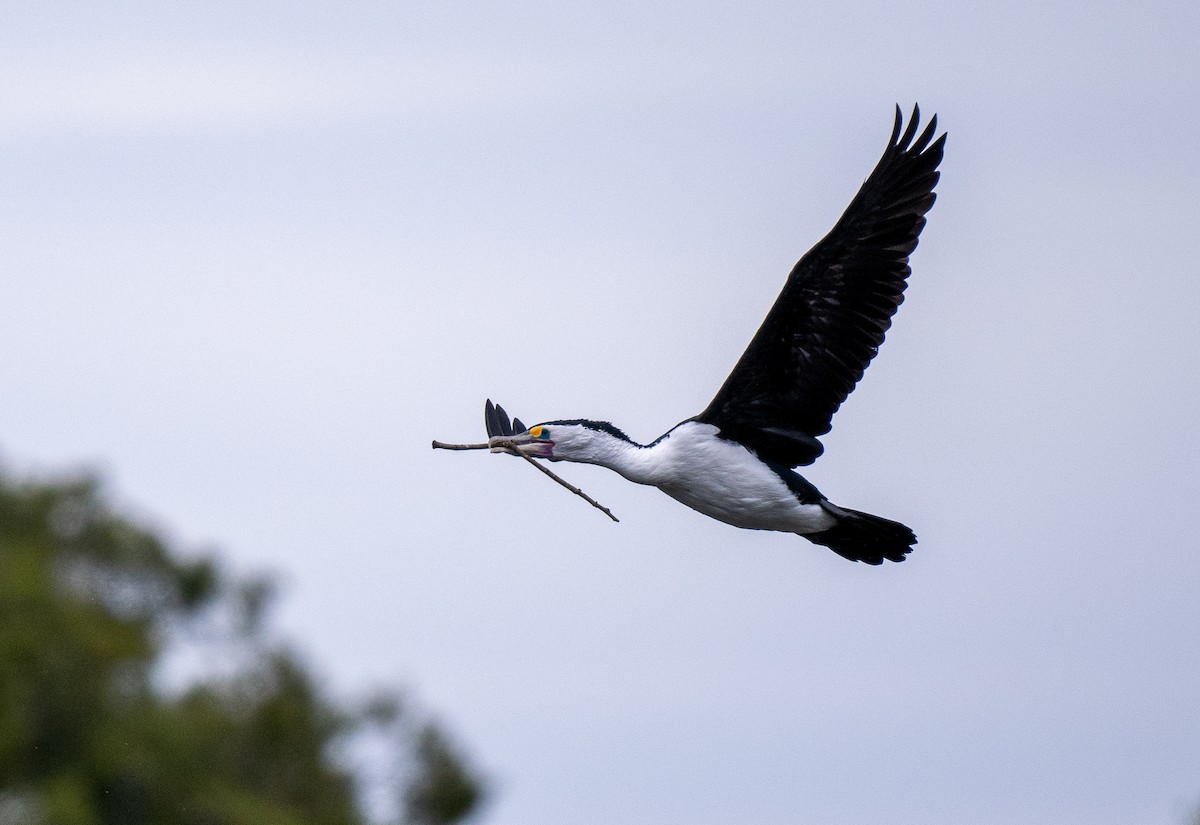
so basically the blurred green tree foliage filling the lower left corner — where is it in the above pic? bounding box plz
[0,474,484,825]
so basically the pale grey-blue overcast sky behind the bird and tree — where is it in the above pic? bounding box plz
[0,1,1200,825]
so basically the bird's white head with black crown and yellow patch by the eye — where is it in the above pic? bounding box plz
[484,402,631,463]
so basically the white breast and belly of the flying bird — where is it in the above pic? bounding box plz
[613,421,836,534]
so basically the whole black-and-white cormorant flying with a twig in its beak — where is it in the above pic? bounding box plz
[485,107,946,565]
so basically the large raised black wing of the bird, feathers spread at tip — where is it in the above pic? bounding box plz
[696,107,946,466]
